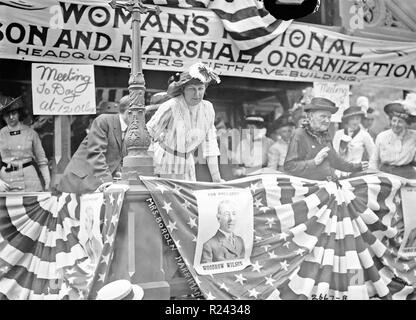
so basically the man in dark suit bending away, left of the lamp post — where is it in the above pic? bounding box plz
[57,96,130,193]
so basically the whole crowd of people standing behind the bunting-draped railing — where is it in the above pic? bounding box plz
[0,63,416,193]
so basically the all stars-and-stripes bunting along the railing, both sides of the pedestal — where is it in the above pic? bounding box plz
[0,174,416,300]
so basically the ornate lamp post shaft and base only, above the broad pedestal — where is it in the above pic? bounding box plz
[110,0,160,181]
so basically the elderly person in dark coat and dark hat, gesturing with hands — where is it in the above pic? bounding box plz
[284,97,368,181]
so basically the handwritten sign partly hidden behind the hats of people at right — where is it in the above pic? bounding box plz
[313,82,350,122]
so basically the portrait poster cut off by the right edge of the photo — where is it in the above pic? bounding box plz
[399,187,416,257]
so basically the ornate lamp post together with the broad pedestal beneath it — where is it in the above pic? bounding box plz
[104,0,169,288]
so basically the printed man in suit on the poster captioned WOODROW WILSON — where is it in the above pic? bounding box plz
[201,200,245,263]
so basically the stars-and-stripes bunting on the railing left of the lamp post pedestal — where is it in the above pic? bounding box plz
[0,188,125,300]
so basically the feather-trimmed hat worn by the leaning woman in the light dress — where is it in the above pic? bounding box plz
[168,62,221,97]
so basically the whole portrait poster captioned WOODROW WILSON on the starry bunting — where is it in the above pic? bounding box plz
[194,188,254,275]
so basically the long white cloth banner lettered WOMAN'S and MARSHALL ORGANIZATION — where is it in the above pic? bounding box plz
[0,0,416,90]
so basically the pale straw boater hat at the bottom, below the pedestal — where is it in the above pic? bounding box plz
[97,279,144,300]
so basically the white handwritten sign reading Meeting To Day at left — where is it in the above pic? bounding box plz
[32,63,96,115]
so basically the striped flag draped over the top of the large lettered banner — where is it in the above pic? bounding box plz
[145,0,292,54]
